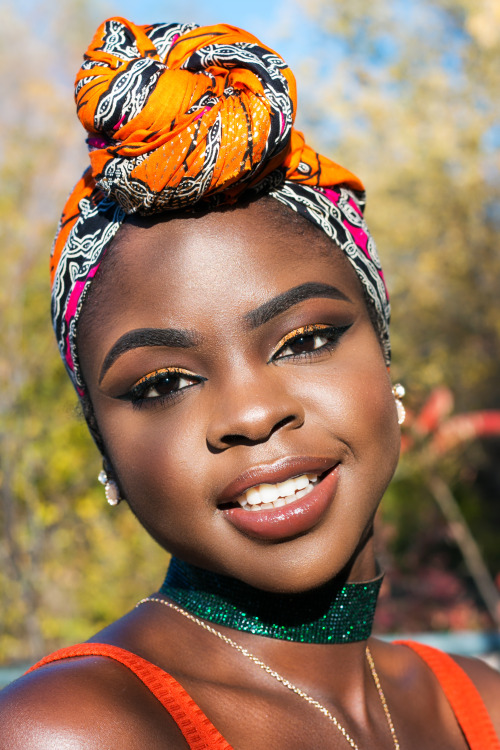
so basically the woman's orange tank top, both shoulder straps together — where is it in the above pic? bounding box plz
[28,641,500,750]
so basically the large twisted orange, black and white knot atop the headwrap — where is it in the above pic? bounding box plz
[75,19,296,214]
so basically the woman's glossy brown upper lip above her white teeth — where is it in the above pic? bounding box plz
[218,456,338,505]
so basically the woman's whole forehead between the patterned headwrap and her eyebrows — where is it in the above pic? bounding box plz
[79,199,363,350]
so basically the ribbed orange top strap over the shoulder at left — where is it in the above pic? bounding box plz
[27,643,232,750]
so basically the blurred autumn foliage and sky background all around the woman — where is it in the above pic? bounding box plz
[0,0,500,663]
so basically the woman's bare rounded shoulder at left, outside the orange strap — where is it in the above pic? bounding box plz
[0,656,187,750]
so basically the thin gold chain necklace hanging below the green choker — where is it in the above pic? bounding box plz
[136,596,400,750]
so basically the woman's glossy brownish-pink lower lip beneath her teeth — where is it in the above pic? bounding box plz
[222,464,339,540]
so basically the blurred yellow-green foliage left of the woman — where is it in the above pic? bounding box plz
[0,1,166,661]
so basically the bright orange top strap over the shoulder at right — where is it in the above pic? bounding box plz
[395,641,500,750]
